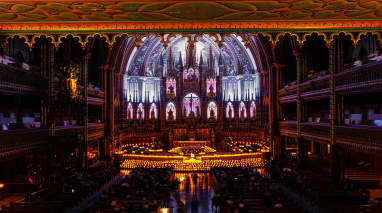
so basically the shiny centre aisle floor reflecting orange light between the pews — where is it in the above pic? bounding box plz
[170,173,214,213]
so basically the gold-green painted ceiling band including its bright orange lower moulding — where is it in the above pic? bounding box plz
[0,0,382,31]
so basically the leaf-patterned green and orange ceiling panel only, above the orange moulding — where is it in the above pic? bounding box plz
[0,0,382,23]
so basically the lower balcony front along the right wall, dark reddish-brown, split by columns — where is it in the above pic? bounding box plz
[279,121,382,151]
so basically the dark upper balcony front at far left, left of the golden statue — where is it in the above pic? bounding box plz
[0,64,48,95]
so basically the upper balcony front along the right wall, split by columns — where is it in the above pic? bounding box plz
[278,61,382,104]
